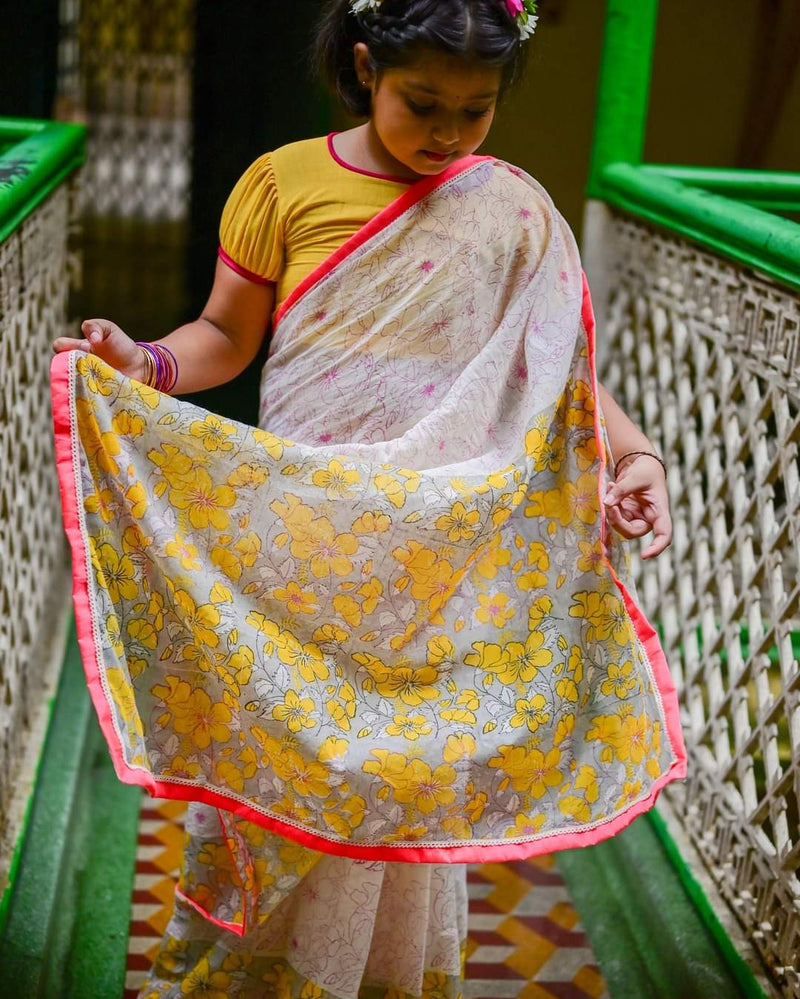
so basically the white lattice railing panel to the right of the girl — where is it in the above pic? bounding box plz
[587,208,800,997]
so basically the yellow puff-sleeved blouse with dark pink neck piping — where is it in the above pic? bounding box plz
[219,136,409,308]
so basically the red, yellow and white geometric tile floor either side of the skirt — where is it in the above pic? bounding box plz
[124,797,608,999]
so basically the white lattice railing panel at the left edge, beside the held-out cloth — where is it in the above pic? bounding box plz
[0,161,76,894]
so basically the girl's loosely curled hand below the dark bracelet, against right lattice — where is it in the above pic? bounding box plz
[605,455,672,558]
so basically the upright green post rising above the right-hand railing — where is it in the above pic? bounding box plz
[588,0,658,197]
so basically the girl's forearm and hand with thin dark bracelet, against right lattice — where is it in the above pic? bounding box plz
[599,385,672,558]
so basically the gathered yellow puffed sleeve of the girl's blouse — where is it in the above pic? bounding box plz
[219,153,283,284]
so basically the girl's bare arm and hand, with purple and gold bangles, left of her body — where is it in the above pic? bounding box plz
[53,260,275,394]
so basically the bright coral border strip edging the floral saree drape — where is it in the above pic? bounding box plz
[52,157,686,863]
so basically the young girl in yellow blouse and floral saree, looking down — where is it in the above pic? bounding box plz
[53,0,685,999]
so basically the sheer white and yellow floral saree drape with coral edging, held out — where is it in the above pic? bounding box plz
[54,160,685,868]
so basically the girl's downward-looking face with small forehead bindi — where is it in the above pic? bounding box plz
[355,43,500,176]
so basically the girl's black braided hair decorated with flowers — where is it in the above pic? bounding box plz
[312,0,526,117]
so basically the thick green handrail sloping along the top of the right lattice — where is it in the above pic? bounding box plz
[595,163,800,289]
